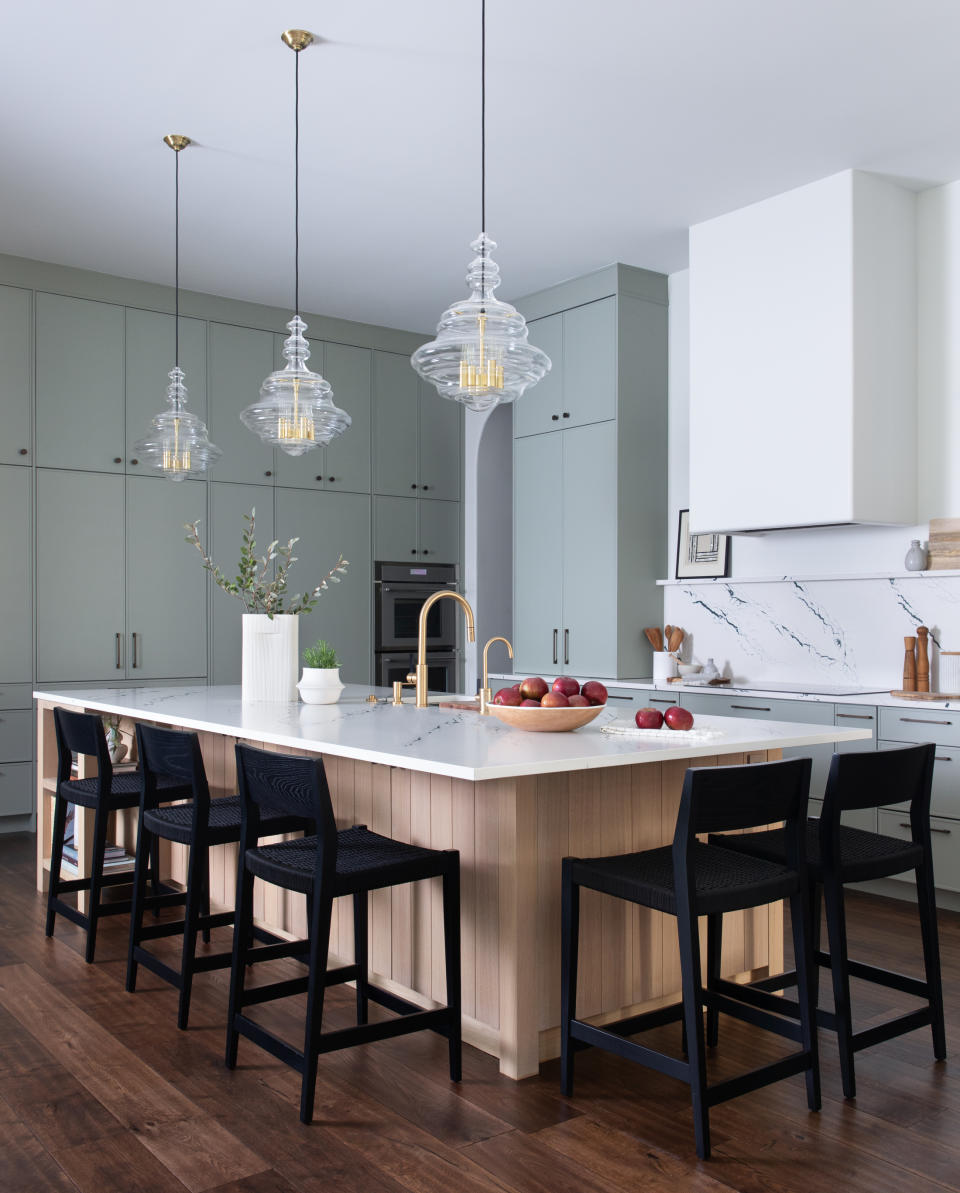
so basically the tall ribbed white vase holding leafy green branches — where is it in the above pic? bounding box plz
[184,509,348,701]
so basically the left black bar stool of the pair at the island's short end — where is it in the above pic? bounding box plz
[560,758,820,1160]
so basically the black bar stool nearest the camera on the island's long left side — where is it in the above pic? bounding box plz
[227,746,460,1123]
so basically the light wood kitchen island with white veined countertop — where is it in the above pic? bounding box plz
[35,686,869,1078]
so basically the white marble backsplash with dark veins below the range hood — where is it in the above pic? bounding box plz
[663,573,960,691]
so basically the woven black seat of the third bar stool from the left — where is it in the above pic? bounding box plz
[246,824,447,895]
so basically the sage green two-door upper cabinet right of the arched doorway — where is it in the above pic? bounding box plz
[514,296,618,435]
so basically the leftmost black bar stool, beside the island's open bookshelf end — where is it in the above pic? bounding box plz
[47,709,190,962]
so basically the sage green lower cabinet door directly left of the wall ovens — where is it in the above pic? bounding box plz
[277,489,373,684]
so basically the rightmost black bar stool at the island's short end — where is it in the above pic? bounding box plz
[707,744,947,1098]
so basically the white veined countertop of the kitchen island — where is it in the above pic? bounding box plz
[33,685,869,781]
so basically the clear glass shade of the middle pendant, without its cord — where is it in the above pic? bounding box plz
[240,315,353,456]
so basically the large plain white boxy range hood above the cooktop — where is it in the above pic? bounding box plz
[690,171,917,533]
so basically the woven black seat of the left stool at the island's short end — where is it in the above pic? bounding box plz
[572,841,797,915]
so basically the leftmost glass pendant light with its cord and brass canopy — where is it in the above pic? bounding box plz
[135,132,223,481]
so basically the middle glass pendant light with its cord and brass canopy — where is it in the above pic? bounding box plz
[240,29,353,456]
